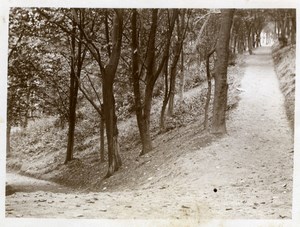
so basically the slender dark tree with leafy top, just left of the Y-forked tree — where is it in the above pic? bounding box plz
[38,9,87,164]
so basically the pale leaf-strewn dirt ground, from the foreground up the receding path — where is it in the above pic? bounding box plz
[5,47,293,223]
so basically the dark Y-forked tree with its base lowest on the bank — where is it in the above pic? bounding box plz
[76,9,123,177]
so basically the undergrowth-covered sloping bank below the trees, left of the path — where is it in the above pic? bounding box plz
[7,56,244,190]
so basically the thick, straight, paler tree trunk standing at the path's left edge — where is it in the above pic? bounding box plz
[211,9,234,134]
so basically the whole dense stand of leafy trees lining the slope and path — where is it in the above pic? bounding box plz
[7,8,296,177]
